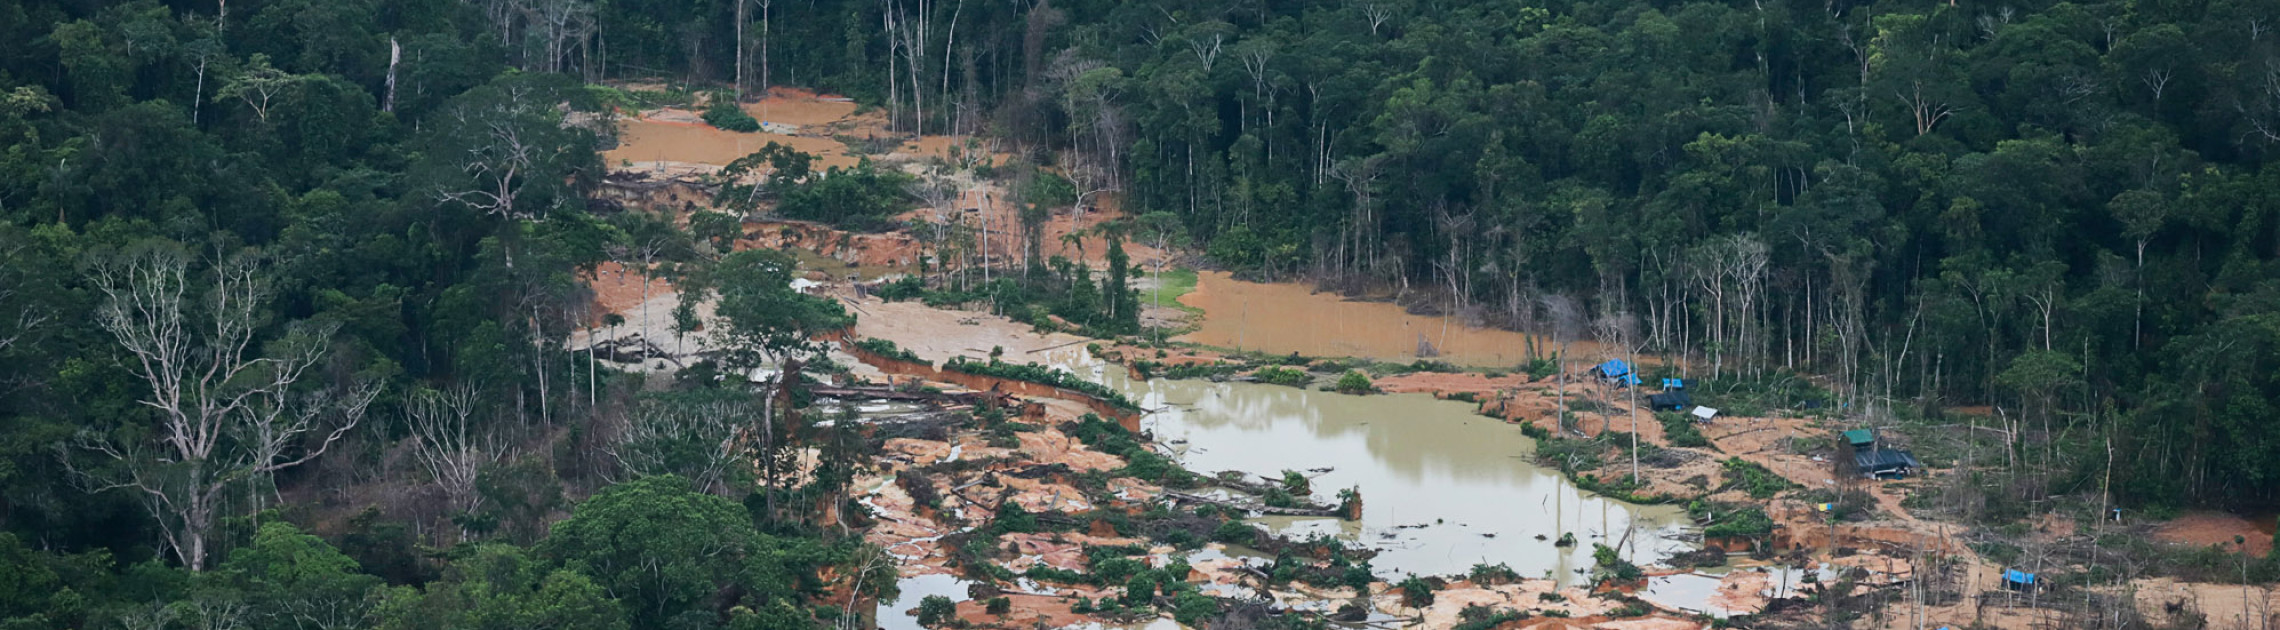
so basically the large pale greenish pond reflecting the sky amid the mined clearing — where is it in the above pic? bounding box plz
[1053,347,1692,584]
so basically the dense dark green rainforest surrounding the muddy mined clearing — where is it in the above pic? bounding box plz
[0,0,2280,628]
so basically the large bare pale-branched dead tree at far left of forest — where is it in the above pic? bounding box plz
[64,244,346,571]
